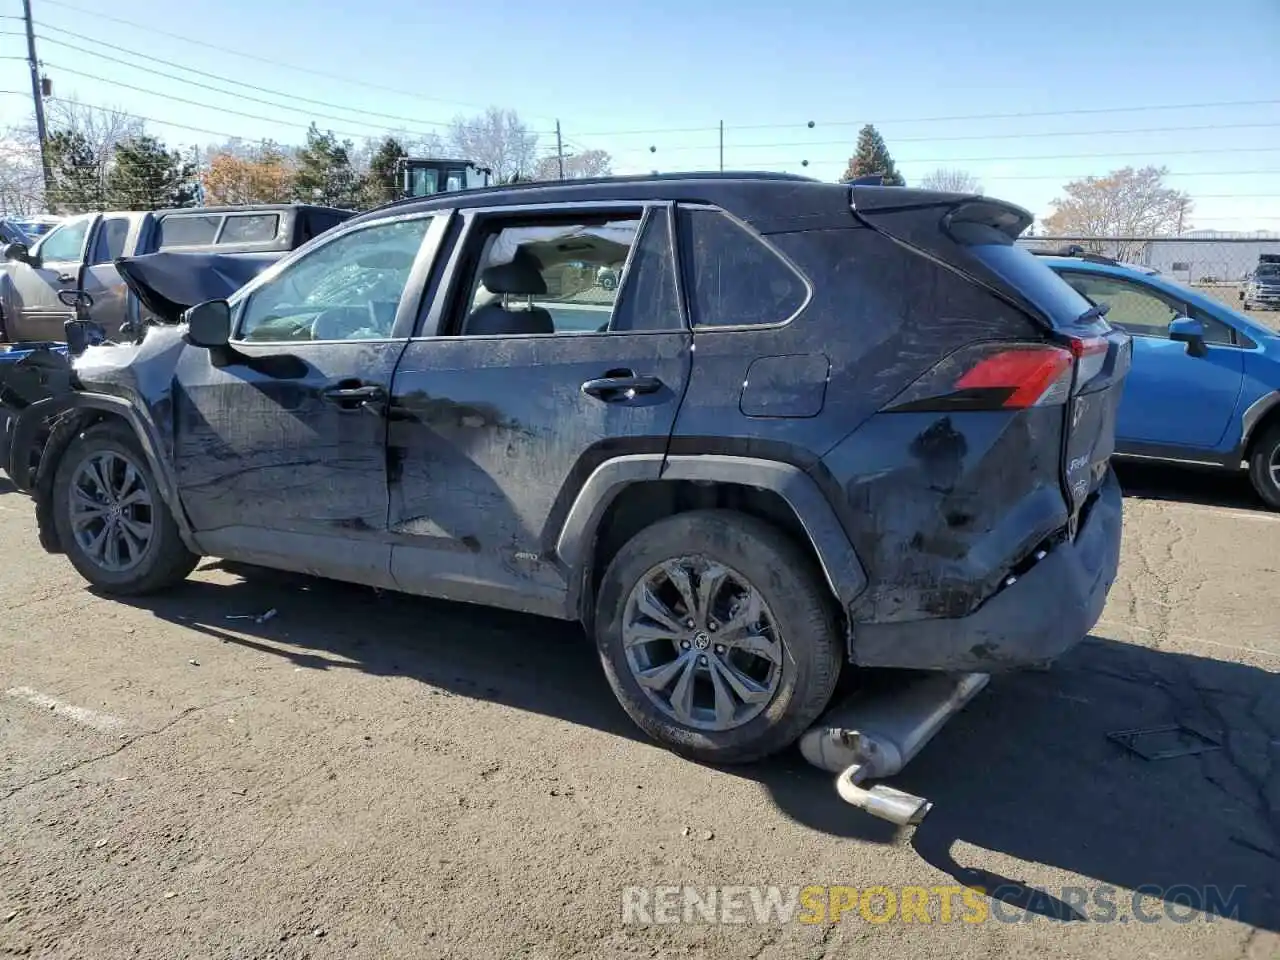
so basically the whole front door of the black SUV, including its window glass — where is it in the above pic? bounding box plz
[174,215,443,586]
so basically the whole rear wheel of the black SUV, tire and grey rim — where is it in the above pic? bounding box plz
[595,511,844,763]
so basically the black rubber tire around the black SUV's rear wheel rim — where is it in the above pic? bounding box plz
[595,509,845,763]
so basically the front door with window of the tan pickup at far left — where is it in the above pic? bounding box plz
[5,214,97,340]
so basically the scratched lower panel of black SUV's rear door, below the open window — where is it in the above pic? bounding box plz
[388,332,690,616]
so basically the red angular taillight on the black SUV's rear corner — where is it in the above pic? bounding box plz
[886,338,1107,411]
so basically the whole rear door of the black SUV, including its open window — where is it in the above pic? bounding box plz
[389,205,692,616]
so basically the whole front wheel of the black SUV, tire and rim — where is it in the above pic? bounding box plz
[52,421,200,595]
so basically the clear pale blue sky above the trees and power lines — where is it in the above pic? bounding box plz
[0,0,1280,230]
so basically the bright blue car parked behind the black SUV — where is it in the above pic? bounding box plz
[1042,256,1280,509]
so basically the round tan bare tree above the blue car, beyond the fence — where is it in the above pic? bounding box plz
[1044,166,1192,260]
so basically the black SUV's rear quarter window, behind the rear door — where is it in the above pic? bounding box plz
[680,207,809,326]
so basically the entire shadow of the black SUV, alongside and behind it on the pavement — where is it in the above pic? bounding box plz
[115,562,1280,931]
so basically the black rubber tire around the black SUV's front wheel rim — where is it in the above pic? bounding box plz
[52,420,200,596]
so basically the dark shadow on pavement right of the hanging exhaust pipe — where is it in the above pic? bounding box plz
[893,636,1280,931]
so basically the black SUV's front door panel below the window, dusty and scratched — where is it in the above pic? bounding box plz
[174,340,404,584]
